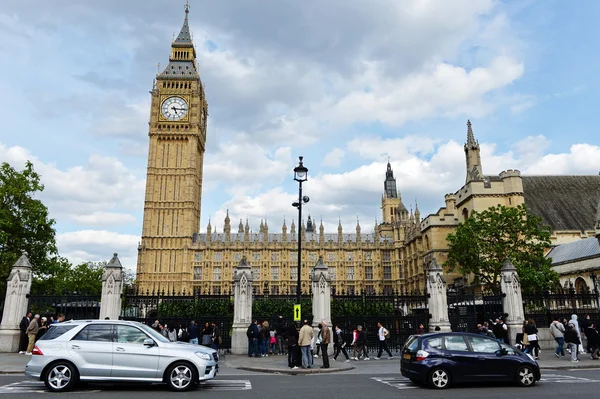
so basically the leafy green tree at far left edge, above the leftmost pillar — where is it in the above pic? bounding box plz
[0,161,57,285]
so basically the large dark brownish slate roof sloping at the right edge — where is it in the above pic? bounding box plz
[522,175,600,231]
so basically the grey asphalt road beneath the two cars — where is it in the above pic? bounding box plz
[0,370,600,399]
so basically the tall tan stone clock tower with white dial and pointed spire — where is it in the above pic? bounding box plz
[137,5,208,292]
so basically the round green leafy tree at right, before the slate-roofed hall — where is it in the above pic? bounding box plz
[445,205,558,292]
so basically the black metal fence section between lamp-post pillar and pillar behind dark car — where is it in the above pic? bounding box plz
[331,293,429,352]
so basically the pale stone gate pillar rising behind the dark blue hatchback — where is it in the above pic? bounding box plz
[427,258,452,331]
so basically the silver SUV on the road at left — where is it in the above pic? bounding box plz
[25,320,219,392]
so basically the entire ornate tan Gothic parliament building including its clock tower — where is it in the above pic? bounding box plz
[137,8,600,294]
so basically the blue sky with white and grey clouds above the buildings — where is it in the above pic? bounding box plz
[0,0,600,268]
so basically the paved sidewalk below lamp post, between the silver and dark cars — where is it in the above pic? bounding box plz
[221,355,355,375]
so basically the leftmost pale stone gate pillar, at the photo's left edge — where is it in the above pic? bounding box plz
[0,252,33,353]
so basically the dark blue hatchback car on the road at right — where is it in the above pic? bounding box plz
[400,332,540,389]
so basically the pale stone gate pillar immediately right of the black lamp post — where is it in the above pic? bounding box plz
[312,256,333,355]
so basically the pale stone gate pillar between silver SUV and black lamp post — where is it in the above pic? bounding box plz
[231,256,252,355]
